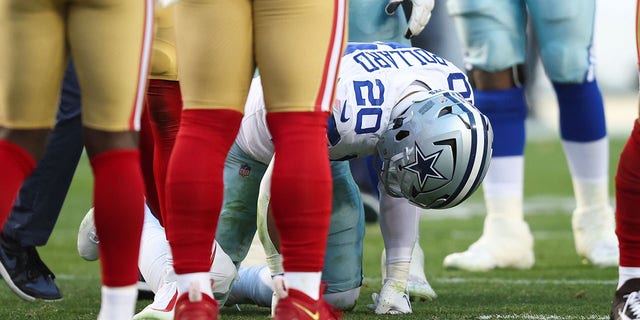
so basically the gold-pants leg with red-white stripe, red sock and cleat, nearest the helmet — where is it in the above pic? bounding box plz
[254,0,346,319]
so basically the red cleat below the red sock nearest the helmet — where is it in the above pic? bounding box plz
[273,289,342,320]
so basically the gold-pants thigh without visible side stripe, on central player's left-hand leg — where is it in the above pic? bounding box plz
[175,0,255,112]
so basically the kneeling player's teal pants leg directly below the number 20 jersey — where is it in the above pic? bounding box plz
[322,161,364,293]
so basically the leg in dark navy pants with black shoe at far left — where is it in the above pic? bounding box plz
[0,59,84,300]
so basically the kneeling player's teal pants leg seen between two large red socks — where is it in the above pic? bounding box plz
[216,143,267,263]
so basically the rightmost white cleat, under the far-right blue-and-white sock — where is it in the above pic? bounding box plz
[571,206,620,268]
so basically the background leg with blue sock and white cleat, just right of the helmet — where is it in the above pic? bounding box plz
[444,0,534,270]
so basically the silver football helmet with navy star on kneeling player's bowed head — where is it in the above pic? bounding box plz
[376,90,493,209]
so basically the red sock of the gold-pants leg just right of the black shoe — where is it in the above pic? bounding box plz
[91,149,144,287]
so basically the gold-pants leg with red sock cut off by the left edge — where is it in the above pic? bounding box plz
[0,1,66,236]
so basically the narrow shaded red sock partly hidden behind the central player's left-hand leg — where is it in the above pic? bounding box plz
[147,79,182,226]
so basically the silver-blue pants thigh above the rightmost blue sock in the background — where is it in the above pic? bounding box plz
[527,0,595,83]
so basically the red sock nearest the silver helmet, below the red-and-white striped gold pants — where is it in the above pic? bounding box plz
[267,112,333,272]
